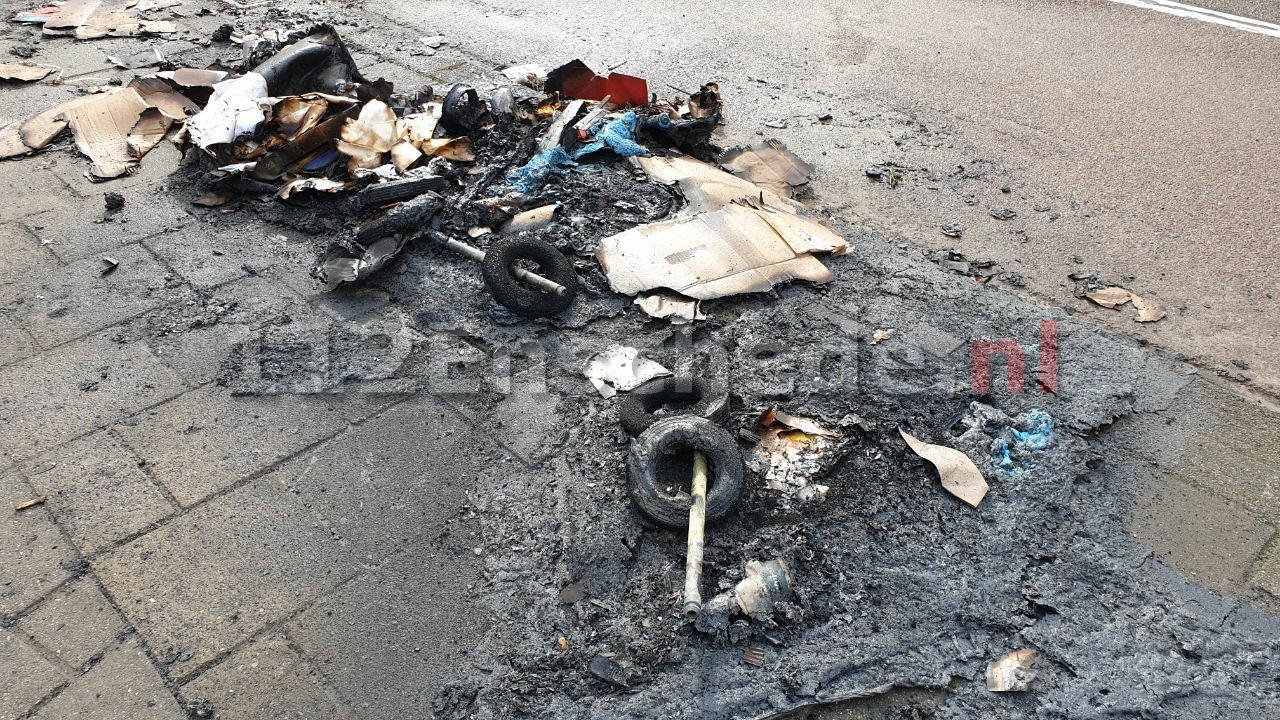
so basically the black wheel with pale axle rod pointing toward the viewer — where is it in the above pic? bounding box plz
[627,415,744,529]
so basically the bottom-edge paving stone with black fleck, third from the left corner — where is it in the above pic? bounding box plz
[182,634,355,720]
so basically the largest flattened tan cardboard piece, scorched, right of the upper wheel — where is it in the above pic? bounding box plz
[596,158,849,300]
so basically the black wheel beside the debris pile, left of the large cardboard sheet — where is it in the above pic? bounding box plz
[480,237,577,318]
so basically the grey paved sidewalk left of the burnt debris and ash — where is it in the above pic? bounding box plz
[0,9,504,720]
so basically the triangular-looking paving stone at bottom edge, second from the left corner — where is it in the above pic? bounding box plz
[35,641,187,720]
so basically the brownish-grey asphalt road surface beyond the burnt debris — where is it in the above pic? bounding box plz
[379,0,1280,396]
